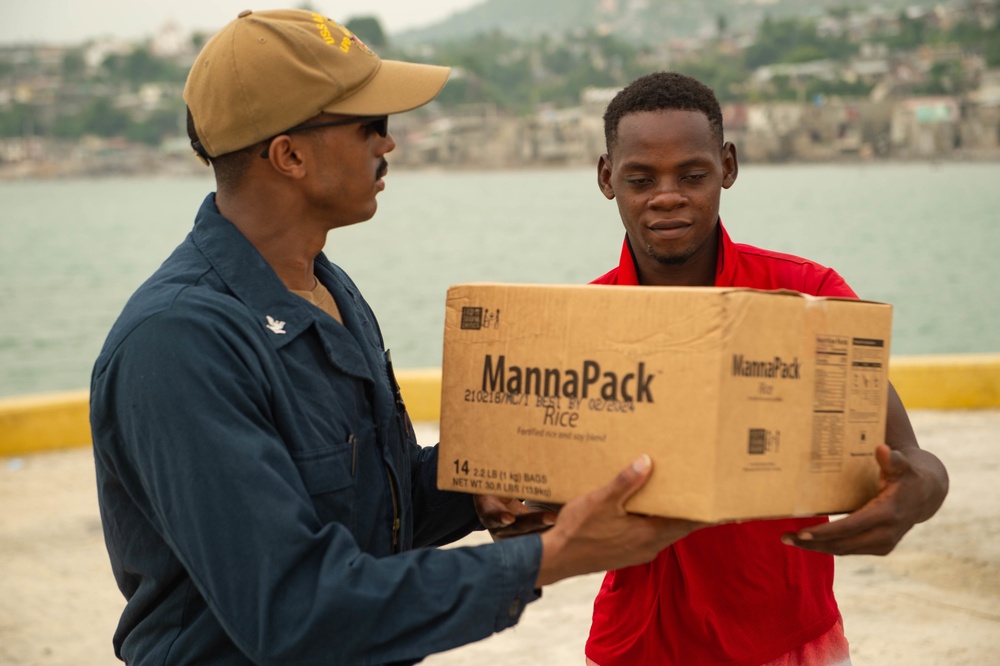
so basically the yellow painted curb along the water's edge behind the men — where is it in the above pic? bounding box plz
[0,354,1000,457]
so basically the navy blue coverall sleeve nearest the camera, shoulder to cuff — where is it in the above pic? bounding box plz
[92,311,541,665]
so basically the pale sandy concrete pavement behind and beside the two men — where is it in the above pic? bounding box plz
[0,409,1000,666]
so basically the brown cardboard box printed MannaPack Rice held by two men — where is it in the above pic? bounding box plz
[438,284,892,521]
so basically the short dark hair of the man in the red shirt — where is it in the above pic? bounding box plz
[604,72,722,154]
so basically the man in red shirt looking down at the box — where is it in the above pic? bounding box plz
[586,73,948,666]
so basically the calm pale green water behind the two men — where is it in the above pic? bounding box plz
[0,164,1000,395]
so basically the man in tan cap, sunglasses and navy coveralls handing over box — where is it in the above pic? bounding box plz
[91,10,696,665]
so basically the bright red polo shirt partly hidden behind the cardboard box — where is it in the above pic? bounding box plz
[586,222,857,666]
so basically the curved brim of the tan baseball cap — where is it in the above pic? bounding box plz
[323,60,451,116]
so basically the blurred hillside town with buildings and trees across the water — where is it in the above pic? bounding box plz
[0,0,1000,179]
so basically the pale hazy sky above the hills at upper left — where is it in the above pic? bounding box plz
[0,0,484,44]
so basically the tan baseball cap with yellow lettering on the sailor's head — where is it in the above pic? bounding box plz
[184,9,450,157]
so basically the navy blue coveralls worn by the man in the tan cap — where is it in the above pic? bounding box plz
[91,195,541,665]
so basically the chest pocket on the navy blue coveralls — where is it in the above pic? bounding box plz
[293,435,358,532]
